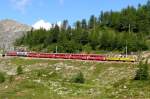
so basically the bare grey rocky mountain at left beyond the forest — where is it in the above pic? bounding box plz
[0,19,32,50]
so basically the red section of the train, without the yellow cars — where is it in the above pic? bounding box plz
[6,51,106,61]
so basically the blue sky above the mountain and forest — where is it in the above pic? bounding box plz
[0,0,147,25]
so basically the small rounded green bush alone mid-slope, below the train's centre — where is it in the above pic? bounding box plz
[71,72,85,83]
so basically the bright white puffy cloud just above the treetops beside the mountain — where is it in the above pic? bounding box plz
[32,20,52,30]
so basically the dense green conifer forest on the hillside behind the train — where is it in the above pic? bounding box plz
[15,1,150,53]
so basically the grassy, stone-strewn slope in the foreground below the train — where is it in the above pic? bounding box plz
[0,58,150,99]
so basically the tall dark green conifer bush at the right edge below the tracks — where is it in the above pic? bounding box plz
[134,60,149,80]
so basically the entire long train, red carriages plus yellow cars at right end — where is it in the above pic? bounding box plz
[6,51,136,62]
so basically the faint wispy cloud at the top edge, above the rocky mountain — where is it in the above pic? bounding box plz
[10,0,31,12]
